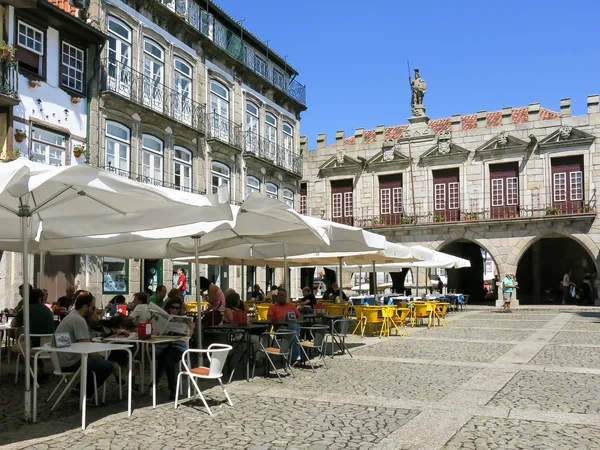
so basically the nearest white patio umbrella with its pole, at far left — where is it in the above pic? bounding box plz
[0,158,231,420]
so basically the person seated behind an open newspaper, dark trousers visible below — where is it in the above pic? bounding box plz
[156,297,194,400]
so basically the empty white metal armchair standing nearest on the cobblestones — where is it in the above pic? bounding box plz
[175,344,233,416]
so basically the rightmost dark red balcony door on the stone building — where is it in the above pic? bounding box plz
[551,156,585,214]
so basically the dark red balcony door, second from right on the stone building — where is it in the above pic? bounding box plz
[490,163,519,219]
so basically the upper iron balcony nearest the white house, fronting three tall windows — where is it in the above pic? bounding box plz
[102,59,206,134]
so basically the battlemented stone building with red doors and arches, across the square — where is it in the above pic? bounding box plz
[300,95,600,303]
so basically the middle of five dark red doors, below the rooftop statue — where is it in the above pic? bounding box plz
[433,169,460,222]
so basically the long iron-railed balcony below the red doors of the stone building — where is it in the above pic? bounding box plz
[344,189,596,228]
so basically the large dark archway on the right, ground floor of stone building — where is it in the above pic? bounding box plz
[515,235,596,305]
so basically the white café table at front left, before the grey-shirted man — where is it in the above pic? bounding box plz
[31,342,132,430]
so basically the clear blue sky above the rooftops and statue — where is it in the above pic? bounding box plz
[217,0,600,149]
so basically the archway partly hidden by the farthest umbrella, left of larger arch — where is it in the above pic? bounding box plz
[440,239,498,302]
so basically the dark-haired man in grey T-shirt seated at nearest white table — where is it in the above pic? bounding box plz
[56,294,119,405]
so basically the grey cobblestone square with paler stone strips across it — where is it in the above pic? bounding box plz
[0,307,600,450]
